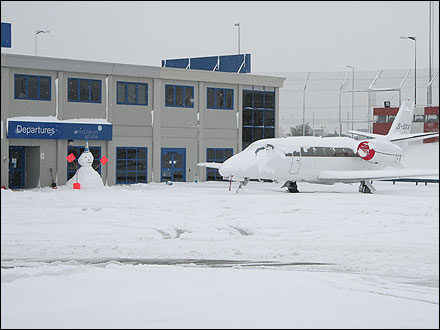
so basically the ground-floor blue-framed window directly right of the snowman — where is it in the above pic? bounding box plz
[116,147,148,184]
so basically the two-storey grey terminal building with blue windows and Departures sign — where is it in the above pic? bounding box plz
[1,54,285,189]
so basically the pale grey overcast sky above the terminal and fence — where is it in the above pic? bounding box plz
[1,1,439,73]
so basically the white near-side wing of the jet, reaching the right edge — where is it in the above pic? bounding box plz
[318,169,439,182]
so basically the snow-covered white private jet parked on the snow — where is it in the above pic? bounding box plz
[197,102,439,193]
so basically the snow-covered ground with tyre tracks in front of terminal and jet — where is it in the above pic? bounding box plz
[1,144,439,328]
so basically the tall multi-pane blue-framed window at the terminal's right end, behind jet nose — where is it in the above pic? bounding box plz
[242,90,275,149]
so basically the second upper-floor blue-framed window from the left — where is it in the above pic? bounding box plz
[67,78,101,103]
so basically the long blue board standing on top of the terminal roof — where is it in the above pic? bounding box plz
[162,54,251,73]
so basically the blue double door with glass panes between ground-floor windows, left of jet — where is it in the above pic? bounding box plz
[160,148,186,182]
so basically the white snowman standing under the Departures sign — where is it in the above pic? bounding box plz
[67,141,104,189]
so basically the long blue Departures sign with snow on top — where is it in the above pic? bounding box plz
[8,121,113,140]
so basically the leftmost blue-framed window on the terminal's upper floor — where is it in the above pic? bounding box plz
[14,74,51,101]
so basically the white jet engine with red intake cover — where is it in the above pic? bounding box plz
[356,140,404,164]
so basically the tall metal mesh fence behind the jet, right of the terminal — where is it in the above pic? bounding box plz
[263,68,439,135]
